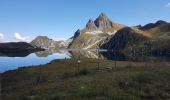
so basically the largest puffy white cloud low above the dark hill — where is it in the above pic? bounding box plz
[14,33,32,42]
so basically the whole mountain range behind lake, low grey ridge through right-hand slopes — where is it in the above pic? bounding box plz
[28,13,170,55]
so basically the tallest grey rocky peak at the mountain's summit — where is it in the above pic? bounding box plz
[94,13,113,30]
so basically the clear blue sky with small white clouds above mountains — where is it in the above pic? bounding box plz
[0,0,170,42]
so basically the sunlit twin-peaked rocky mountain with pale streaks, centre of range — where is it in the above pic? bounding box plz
[68,13,124,49]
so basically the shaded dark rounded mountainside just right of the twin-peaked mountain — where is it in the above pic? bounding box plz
[101,27,148,51]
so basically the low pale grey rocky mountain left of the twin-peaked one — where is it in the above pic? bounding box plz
[31,36,72,49]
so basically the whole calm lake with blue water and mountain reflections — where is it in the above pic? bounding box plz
[0,50,169,73]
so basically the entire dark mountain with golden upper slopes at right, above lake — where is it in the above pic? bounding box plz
[101,21,170,55]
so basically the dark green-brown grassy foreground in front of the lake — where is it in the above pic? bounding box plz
[1,59,170,100]
